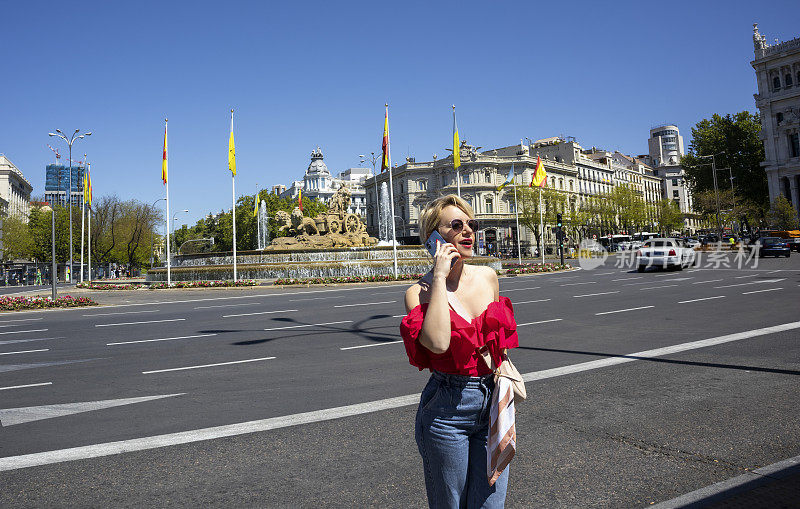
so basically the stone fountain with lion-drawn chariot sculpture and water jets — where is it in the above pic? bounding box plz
[147,187,500,281]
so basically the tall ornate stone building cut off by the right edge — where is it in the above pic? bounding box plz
[750,24,800,214]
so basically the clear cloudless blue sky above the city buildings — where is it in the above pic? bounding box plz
[0,0,800,223]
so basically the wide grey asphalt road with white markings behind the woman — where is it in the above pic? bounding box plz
[0,256,800,507]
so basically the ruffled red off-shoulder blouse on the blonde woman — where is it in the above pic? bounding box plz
[400,297,519,376]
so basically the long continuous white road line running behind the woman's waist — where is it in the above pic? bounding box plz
[6,322,800,472]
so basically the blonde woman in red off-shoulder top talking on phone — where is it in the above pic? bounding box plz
[400,194,518,508]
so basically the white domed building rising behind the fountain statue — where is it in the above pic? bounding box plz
[280,147,372,217]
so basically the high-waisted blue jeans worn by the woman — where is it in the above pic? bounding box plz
[415,371,509,509]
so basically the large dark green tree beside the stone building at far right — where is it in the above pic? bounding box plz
[680,111,769,210]
